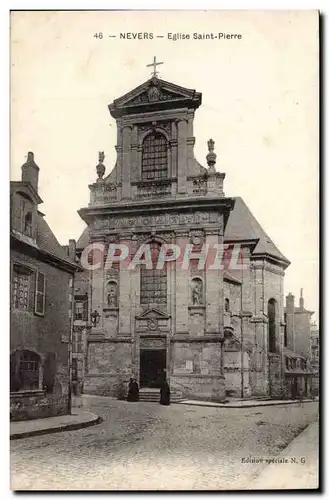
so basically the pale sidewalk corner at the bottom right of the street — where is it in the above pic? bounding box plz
[245,421,319,490]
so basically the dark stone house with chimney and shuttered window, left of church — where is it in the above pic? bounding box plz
[10,152,78,420]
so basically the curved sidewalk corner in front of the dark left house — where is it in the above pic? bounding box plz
[10,408,102,439]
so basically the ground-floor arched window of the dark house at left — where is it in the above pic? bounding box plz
[10,350,41,392]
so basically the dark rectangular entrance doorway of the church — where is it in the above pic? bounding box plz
[140,349,166,388]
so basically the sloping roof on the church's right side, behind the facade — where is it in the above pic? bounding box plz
[224,197,290,264]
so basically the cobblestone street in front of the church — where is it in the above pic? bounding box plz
[11,396,318,490]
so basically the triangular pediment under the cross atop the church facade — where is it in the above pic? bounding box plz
[109,77,201,117]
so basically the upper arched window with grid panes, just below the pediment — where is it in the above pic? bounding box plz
[142,132,168,180]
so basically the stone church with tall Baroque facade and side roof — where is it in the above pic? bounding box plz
[76,69,310,401]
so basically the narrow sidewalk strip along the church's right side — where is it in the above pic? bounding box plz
[176,398,318,408]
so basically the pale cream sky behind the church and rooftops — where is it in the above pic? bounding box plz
[11,10,319,319]
